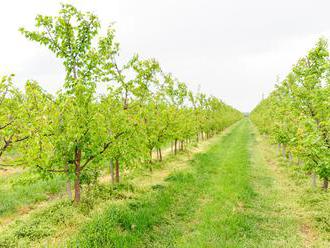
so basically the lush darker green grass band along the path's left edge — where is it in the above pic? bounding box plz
[70,120,244,247]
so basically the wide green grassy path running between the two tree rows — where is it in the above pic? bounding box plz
[71,120,327,247]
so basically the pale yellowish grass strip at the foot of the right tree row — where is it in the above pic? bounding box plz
[257,128,330,247]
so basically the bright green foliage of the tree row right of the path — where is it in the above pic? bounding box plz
[251,39,330,188]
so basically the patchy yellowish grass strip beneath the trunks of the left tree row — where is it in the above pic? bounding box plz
[0,126,224,247]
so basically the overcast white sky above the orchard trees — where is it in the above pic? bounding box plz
[0,0,330,112]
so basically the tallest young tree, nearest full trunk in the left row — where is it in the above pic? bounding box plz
[20,4,118,202]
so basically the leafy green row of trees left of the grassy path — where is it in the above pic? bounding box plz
[0,4,242,202]
